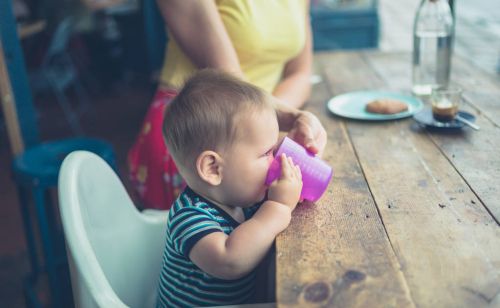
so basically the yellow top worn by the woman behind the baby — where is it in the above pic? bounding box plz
[161,0,308,92]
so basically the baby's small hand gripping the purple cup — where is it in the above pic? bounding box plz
[267,154,302,210]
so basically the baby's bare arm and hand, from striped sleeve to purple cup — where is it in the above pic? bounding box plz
[189,155,302,279]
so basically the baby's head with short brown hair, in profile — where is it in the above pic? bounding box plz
[163,70,279,207]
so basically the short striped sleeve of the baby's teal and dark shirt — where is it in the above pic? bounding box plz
[170,207,224,258]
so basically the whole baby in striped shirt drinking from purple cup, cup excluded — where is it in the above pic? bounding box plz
[158,70,302,307]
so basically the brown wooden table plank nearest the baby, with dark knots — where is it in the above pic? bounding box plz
[276,55,415,307]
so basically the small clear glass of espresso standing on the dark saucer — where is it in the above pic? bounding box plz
[431,87,462,122]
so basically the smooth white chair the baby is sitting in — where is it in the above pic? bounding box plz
[59,151,167,307]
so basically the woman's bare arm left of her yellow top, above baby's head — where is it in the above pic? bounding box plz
[157,0,244,78]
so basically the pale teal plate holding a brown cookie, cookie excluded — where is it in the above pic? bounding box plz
[327,91,423,121]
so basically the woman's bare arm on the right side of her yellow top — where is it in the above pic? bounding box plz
[273,2,313,108]
